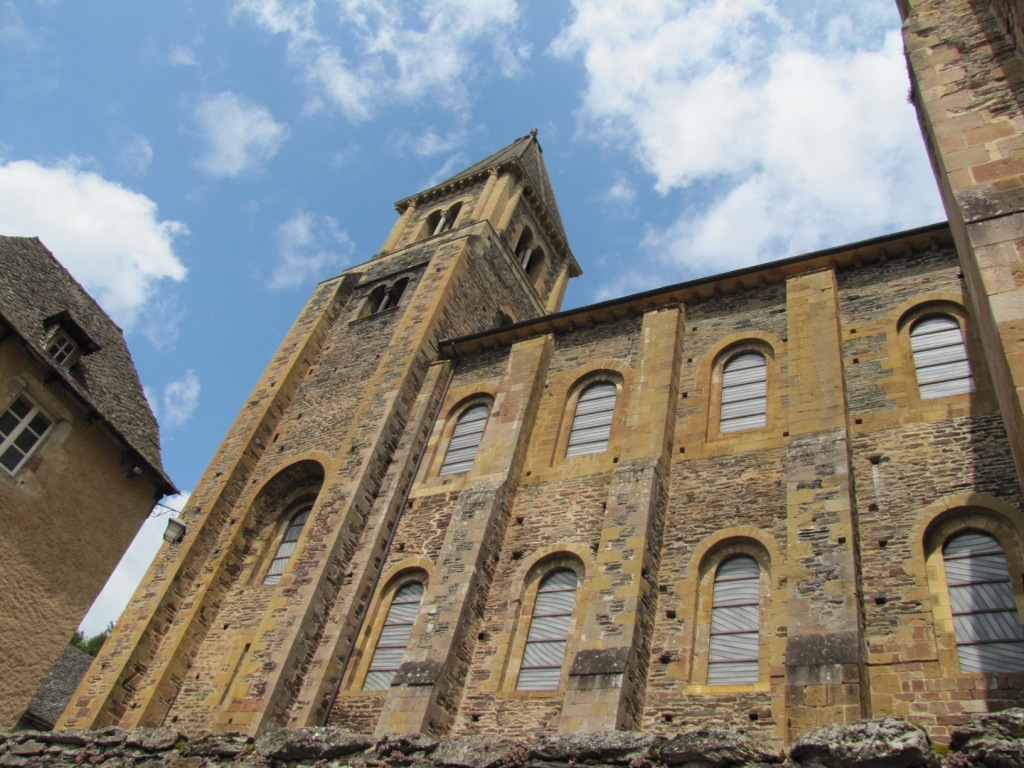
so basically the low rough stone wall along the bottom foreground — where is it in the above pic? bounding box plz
[0,709,1024,768]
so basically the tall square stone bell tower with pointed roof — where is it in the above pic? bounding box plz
[57,130,580,734]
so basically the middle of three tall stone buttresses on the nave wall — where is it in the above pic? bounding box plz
[559,307,683,733]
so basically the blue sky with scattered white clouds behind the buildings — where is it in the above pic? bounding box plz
[0,0,943,634]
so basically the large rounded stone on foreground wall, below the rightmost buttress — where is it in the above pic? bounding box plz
[790,718,937,768]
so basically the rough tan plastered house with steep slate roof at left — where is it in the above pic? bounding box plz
[0,237,176,729]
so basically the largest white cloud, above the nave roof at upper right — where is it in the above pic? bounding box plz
[552,0,942,272]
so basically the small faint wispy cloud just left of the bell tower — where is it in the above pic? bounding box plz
[269,211,354,289]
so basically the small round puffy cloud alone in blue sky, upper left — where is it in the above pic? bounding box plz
[195,91,288,176]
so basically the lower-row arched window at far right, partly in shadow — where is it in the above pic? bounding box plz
[942,530,1024,672]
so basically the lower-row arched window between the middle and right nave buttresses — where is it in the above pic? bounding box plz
[708,555,761,685]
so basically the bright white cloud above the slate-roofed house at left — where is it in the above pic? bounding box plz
[0,158,188,330]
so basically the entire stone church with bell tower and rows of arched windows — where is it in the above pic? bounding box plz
[58,0,1024,744]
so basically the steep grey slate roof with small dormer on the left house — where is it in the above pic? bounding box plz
[0,236,177,494]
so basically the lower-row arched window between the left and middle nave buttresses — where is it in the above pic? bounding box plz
[516,568,578,690]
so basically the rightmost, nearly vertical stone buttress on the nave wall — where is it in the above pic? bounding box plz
[785,269,868,736]
